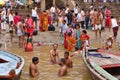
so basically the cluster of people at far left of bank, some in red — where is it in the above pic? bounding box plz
[0,8,35,51]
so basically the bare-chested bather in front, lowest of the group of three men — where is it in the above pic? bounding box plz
[58,58,67,77]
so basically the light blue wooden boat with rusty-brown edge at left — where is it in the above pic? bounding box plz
[0,51,25,80]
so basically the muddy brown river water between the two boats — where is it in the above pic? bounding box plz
[9,46,92,80]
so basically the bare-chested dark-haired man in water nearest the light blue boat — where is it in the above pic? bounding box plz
[29,57,39,77]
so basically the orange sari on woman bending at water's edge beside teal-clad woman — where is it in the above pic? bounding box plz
[66,36,76,51]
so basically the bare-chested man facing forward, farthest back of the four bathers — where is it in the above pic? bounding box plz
[50,44,59,64]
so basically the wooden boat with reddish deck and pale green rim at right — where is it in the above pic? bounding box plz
[82,49,120,80]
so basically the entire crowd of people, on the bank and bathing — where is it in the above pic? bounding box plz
[0,0,120,77]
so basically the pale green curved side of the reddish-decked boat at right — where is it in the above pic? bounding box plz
[82,51,118,80]
